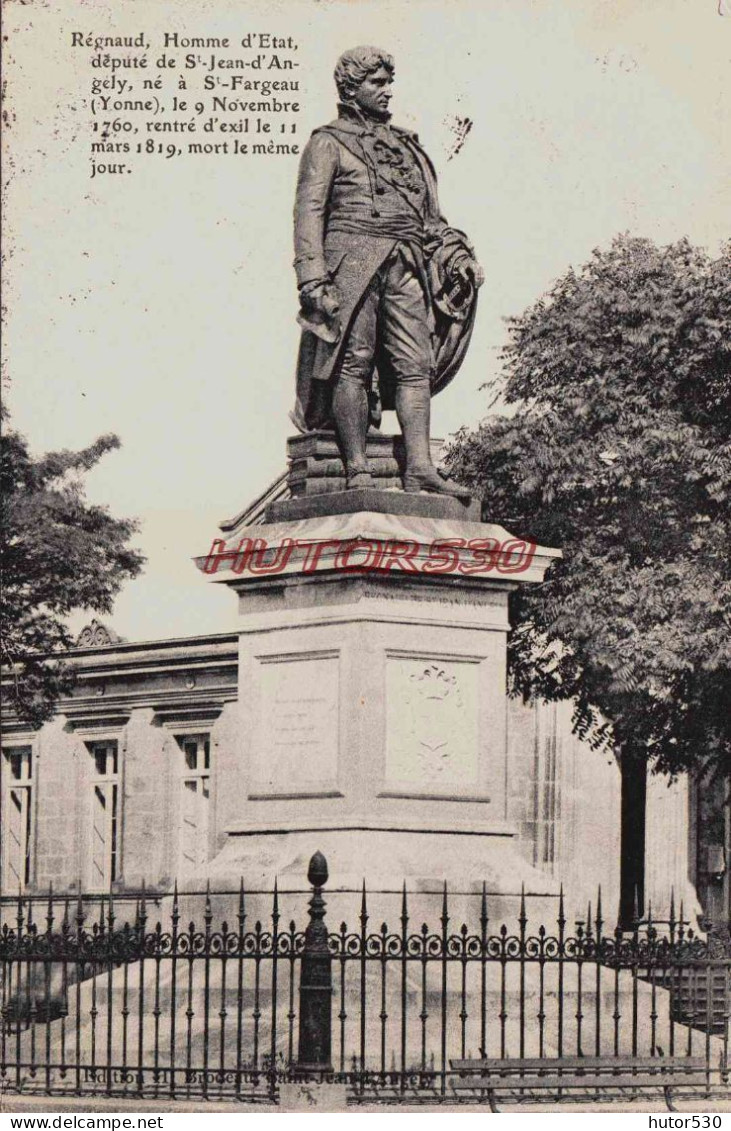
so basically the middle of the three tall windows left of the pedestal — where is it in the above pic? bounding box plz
[88,742,120,891]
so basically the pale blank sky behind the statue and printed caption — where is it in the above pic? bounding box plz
[3,0,731,640]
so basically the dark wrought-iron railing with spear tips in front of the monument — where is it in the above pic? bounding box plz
[0,853,731,1103]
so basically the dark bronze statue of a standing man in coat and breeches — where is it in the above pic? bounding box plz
[293,48,483,497]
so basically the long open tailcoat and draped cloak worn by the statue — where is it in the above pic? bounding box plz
[293,116,476,431]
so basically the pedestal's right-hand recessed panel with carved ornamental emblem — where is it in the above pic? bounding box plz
[386,655,480,795]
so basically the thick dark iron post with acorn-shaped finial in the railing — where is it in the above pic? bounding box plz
[296,852,333,1073]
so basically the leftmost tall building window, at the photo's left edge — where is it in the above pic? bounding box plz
[0,746,33,895]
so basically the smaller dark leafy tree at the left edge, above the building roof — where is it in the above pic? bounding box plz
[0,420,145,727]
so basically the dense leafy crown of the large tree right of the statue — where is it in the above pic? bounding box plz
[448,236,731,774]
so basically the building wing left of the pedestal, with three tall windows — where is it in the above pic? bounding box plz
[1,632,238,895]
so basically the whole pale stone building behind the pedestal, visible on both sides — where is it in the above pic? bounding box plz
[0,624,710,924]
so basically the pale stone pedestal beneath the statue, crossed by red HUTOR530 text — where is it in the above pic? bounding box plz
[197,436,558,916]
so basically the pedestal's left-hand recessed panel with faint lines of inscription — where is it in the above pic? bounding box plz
[253,653,339,797]
